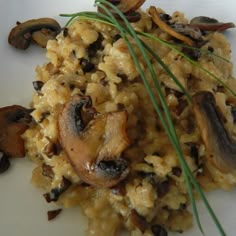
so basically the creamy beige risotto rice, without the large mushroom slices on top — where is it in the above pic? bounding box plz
[23,6,236,236]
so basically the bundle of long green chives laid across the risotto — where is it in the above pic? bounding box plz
[61,0,228,236]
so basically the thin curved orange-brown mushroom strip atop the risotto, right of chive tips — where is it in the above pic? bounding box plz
[149,6,194,46]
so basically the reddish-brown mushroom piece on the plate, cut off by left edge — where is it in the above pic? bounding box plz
[0,105,31,157]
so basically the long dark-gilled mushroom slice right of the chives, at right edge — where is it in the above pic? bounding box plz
[193,91,236,172]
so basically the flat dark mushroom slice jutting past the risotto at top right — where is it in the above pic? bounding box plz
[190,16,235,31]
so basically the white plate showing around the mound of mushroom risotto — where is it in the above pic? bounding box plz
[0,0,236,236]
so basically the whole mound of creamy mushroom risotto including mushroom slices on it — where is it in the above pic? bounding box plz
[20,1,236,236]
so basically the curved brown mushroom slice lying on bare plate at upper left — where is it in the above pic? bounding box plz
[8,18,61,49]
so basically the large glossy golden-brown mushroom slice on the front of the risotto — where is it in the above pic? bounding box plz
[58,95,129,188]
